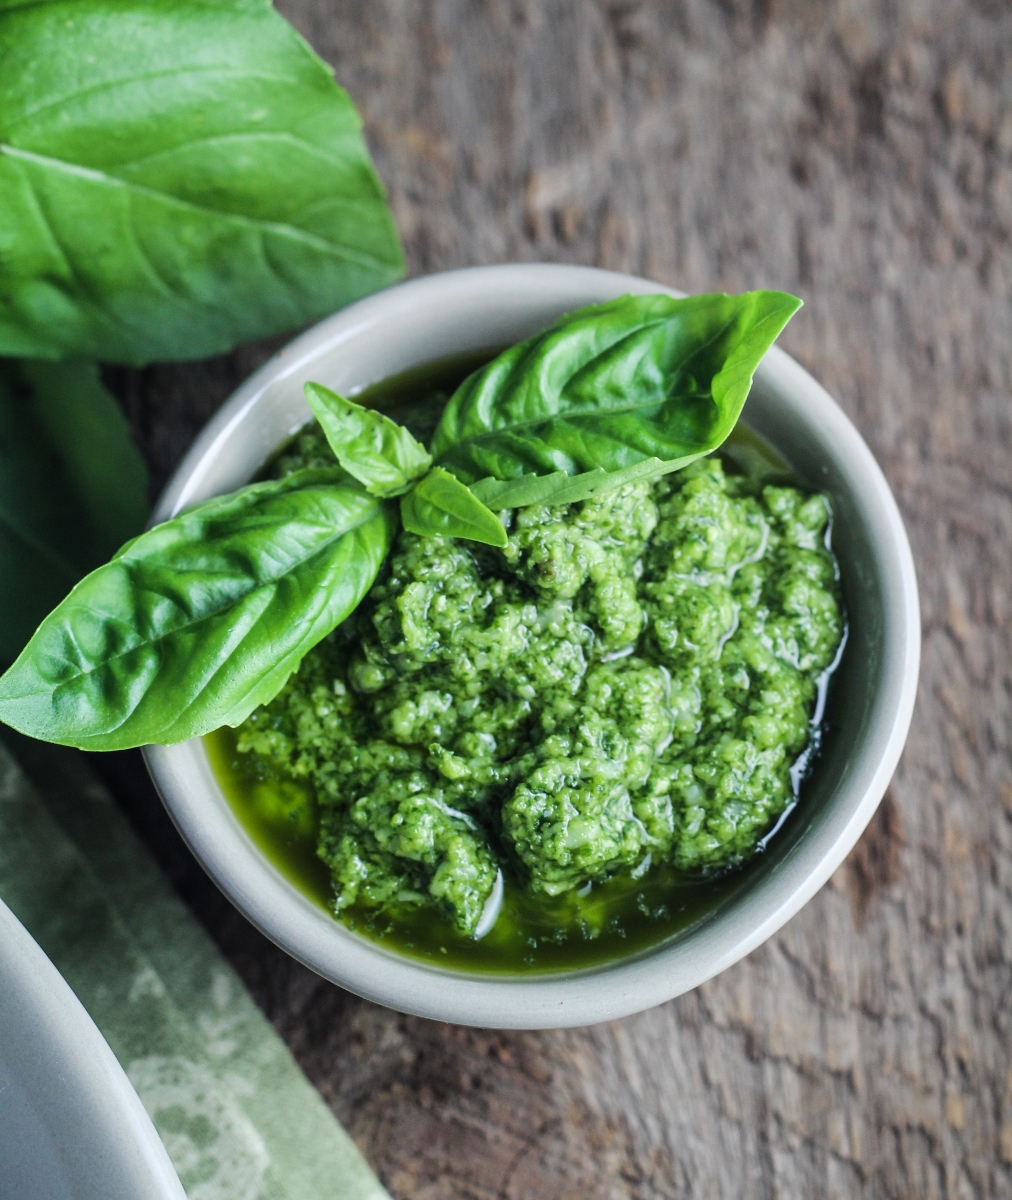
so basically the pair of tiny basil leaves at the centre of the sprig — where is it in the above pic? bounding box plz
[305,383,507,547]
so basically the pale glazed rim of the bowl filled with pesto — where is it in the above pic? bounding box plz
[144,264,921,1028]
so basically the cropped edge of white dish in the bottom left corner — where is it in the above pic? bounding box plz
[0,902,186,1200]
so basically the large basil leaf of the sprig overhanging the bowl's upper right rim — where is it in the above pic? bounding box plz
[432,292,801,508]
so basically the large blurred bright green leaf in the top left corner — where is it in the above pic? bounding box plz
[0,0,403,364]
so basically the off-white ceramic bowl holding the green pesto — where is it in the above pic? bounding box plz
[145,265,921,1028]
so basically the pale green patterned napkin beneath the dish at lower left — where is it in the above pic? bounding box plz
[0,740,389,1200]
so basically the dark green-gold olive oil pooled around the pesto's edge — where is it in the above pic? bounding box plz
[204,352,834,976]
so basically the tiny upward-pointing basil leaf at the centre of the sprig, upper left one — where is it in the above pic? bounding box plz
[305,383,432,496]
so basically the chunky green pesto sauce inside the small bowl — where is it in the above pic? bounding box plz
[210,369,844,970]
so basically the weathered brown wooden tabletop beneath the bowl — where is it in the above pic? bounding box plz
[104,0,1012,1200]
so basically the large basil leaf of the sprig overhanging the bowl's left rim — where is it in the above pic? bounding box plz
[0,468,394,750]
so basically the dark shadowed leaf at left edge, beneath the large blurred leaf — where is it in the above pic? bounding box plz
[0,360,148,662]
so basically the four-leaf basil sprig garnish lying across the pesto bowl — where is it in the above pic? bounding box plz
[0,292,801,750]
